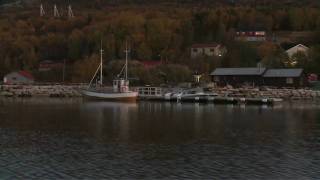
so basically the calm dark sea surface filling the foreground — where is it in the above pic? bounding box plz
[0,98,320,179]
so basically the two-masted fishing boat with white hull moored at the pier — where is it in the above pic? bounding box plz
[81,42,138,101]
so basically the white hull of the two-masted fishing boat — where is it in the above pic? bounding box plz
[81,90,138,101]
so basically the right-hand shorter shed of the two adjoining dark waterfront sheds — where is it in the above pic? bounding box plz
[263,68,308,87]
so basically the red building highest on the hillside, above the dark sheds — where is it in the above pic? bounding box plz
[235,30,267,42]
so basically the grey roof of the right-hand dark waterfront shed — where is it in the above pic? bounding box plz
[263,68,303,77]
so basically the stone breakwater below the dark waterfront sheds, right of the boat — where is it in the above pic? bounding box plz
[212,88,320,100]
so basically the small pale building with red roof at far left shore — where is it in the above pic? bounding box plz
[3,71,34,84]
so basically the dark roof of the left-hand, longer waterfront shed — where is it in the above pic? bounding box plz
[210,68,266,76]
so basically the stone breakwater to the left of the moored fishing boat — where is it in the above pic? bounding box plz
[0,85,85,97]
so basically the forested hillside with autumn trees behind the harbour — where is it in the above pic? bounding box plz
[0,0,320,84]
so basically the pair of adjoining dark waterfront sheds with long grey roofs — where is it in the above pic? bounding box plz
[210,68,308,87]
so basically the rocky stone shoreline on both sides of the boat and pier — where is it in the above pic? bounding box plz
[0,84,320,100]
